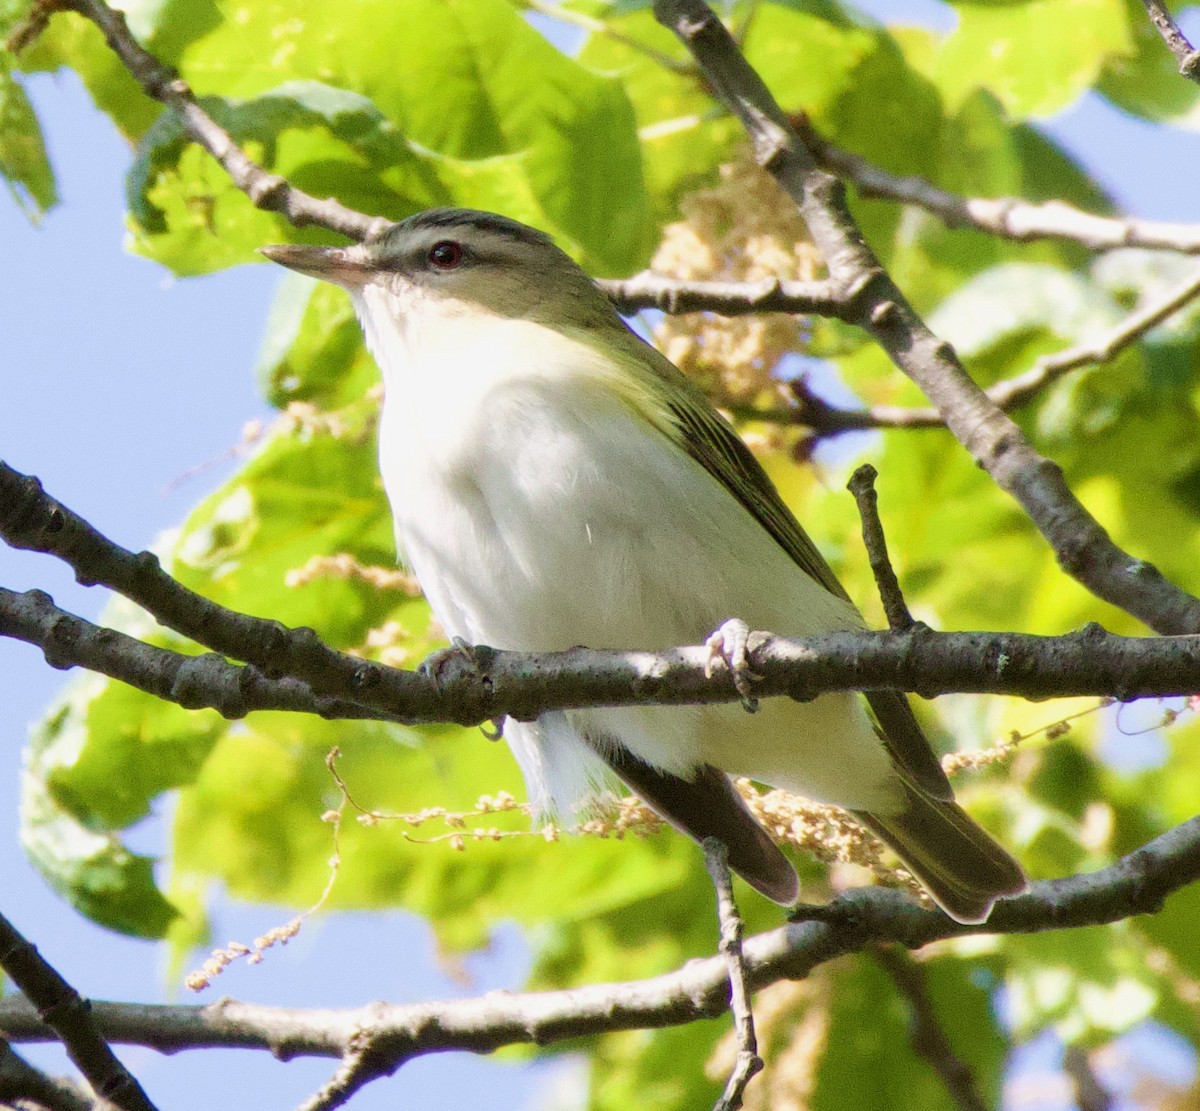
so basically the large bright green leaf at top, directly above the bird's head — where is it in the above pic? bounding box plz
[168,0,653,274]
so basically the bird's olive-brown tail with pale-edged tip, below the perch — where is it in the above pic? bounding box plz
[853,783,1028,924]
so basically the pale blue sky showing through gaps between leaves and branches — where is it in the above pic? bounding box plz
[7,2,1200,1111]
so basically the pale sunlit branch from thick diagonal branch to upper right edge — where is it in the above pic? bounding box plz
[791,115,1200,254]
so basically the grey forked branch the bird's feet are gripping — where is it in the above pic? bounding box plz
[7,463,1200,725]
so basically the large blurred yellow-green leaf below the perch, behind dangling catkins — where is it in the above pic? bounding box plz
[166,714,712,969]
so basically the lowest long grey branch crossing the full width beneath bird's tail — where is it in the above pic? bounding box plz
[0,818,1200,1065]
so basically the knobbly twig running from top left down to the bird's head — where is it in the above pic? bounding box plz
[54,0,388,239]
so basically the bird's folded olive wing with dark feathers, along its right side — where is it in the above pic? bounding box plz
[633,348,954,799]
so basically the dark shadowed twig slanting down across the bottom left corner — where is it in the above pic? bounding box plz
[0,914,155,1111]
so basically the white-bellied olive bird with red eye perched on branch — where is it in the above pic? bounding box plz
[264,209,1025,923]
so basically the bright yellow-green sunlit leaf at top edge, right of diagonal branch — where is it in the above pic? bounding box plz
[937,0,1133,120]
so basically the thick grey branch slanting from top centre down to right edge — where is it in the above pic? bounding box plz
[654,0,1200,633]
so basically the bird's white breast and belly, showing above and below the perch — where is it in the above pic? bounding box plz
[360,289,896,810]
